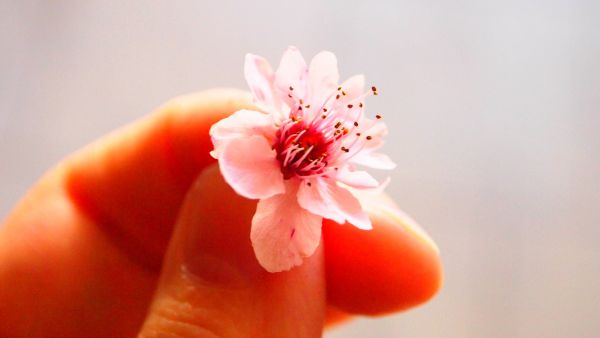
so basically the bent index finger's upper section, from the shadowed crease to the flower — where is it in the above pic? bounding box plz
[66,90,250,271]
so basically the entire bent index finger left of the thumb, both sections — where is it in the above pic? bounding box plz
[0,90,248,337]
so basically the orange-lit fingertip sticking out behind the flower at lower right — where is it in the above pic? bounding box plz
[323,210,442,315]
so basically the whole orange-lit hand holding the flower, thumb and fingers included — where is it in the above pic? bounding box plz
[0,90,442,337]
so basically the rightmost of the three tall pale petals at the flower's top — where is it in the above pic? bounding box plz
[308,51,340,107]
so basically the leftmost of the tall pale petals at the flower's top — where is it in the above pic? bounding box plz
[244,54,281,113]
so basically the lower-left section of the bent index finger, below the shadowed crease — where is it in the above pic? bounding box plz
[0,166,156,338]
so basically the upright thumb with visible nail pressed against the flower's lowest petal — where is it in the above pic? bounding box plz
[140,165,326,337]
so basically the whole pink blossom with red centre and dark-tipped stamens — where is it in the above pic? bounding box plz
[210,47,395,272]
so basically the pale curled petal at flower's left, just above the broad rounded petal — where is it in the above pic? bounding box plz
[208,109,276,158]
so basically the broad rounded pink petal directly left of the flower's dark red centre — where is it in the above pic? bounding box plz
[219,136,285,199]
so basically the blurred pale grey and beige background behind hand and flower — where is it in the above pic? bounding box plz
[0,0,600,338]
